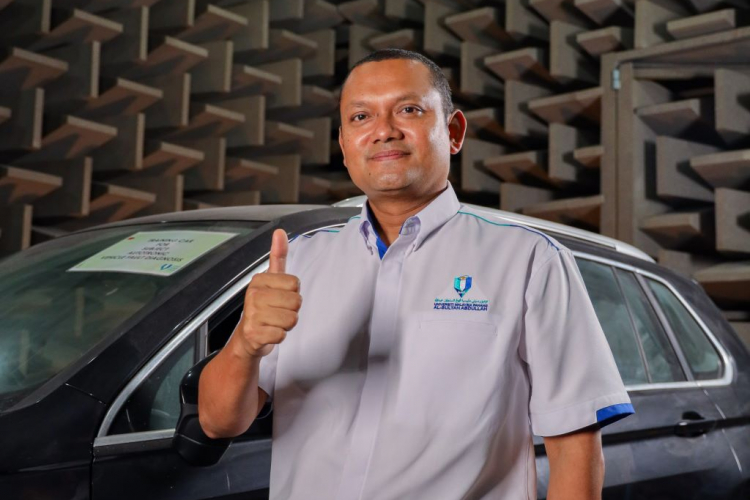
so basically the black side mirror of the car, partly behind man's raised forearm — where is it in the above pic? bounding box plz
[172,351,232,467]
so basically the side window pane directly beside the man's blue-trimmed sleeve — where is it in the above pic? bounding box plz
[576,259,648,384]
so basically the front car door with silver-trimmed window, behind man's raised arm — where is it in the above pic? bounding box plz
[92,220,350,500]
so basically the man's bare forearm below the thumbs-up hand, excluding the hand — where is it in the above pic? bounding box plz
[198,334,260,438]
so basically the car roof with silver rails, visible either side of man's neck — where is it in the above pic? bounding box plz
[73,196,655,262]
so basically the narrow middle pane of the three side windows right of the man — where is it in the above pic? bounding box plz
[615,269,686,382]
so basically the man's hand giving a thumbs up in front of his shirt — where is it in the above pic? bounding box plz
[227,229,302,359]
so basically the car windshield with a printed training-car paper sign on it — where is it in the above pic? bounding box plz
[0,221,264,411]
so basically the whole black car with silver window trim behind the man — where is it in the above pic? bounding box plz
[0,198,750,500]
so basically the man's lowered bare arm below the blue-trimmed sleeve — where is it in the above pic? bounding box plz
[545,429,604,500]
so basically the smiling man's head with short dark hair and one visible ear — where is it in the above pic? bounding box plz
[339,59,466,198]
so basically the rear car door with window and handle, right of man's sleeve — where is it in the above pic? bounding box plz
[537,251,733,500]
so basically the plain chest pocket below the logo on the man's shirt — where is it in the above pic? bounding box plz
[395,311,500,428]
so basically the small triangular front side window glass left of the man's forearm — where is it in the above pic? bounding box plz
[109,336,195,434]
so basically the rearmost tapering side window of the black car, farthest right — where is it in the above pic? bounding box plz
[647,279,722,380]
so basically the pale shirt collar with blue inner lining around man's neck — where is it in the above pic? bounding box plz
[359,181,461,258]
